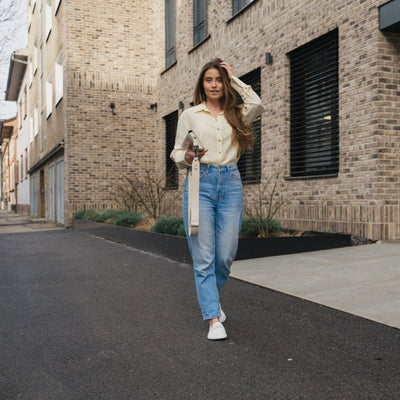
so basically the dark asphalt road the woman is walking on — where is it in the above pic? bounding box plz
[0,229,400,400]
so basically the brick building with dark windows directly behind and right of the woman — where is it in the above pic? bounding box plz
[158,0,400,239]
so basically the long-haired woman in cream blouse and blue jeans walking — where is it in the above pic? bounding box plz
[171,59,265,340]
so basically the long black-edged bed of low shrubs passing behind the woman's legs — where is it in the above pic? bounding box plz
[72,210,352,263]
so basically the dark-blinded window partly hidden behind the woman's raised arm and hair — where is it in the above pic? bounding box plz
[238,68,261,183]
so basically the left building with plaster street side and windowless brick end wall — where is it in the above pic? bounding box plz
[28,0,163,225]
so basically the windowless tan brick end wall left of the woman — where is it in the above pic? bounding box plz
[64,0,160,223]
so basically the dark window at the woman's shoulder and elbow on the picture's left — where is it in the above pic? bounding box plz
[164,111,179,189]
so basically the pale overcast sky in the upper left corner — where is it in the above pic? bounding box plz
[0,0,28,119]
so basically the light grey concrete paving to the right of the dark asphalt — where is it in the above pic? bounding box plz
[231,241,400,329]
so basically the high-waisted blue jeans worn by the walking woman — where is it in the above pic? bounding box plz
[183,164,243,320]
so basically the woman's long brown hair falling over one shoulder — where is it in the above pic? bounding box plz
[194,58,254,155]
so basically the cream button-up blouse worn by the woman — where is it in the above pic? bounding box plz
[171,76,265,168]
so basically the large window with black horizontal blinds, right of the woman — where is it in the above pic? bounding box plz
[289,30,339,177]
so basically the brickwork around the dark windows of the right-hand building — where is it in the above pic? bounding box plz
[159,0,400,239]
